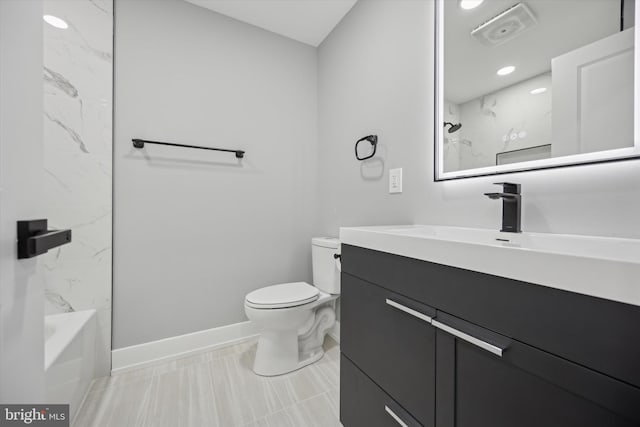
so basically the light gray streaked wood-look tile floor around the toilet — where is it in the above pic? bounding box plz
[74,338,341,427]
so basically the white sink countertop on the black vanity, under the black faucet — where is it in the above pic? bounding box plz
[340,225,640,306]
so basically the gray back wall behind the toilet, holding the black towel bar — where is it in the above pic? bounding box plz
[113,0,317,348]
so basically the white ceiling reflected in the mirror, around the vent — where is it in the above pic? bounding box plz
[444,0,620,104]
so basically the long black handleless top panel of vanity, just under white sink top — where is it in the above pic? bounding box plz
[342,245,640,387]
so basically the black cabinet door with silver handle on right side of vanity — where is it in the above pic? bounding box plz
[434,313,640,427]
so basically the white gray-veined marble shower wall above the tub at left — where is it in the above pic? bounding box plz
[43,0,113,375]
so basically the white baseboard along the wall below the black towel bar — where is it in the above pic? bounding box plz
[111,321,258,375]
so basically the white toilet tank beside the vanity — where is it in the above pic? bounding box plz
[311,237,340,295]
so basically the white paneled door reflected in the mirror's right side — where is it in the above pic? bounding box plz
[551,29,634,157]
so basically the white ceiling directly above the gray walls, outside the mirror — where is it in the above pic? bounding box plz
[185,0,357,46]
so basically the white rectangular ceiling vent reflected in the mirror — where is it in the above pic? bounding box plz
[471,3,538,46]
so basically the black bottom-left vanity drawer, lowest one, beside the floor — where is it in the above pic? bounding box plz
[340,355,422,427]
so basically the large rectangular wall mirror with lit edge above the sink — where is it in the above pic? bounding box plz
[435,0,640,180]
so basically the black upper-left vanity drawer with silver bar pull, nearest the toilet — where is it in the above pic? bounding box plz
[340,273,436,427]
